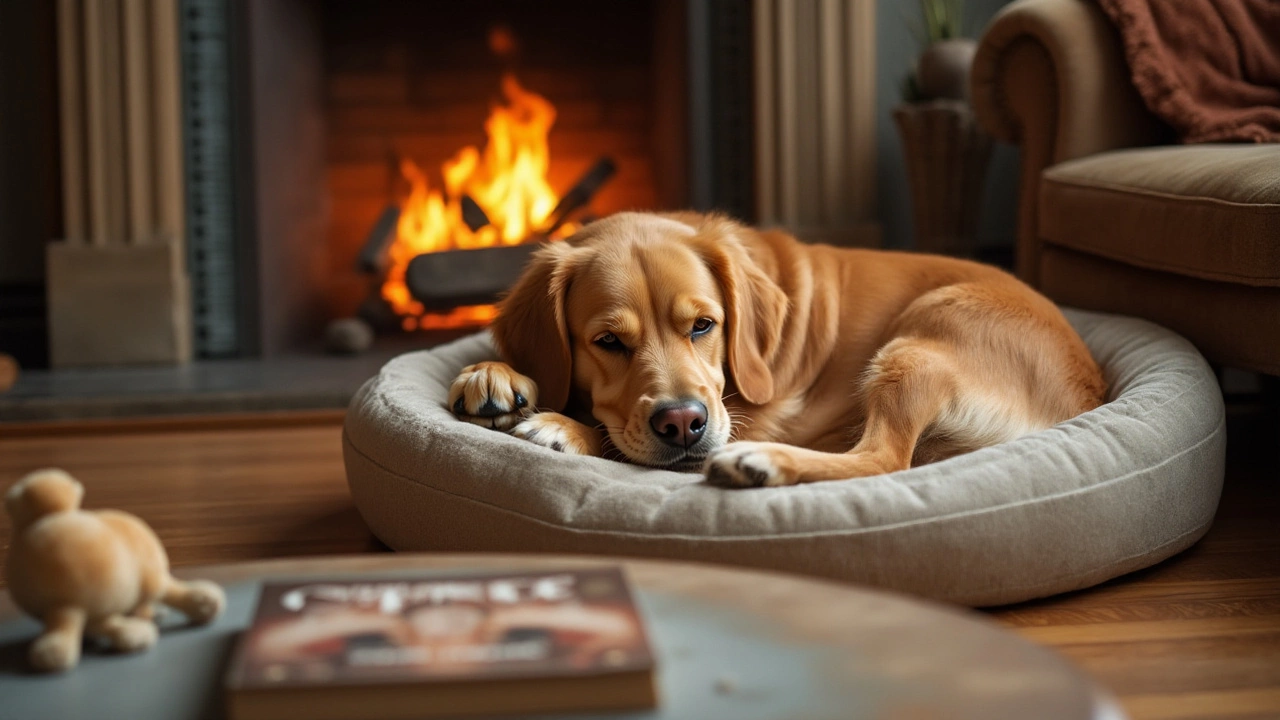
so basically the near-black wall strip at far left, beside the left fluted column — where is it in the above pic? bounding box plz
[0,0,61,368]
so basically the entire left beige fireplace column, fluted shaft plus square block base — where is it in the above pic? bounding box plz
[46,0,191,366]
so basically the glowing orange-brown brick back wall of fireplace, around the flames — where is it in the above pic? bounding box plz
[319,0,685,325]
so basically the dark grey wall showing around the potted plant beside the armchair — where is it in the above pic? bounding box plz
[876,0,1018,254]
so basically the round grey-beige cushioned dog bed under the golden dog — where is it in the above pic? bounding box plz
[343,311,1226,606]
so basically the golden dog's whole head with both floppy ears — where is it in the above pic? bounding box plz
[493,213,787,469]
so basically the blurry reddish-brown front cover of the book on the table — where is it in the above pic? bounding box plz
[228,568,653,689]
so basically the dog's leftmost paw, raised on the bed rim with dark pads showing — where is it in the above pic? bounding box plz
[448,363,538,430]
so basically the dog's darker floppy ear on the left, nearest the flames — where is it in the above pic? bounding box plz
[490,242,575,413]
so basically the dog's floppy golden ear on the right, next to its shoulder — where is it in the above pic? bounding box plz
[695,222,790,405]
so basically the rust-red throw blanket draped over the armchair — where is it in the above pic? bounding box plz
[1101,0,1280,142]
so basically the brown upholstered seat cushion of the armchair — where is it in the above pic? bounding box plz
[1038,145,1280,287]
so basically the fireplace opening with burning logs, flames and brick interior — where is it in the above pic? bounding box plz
[318,0,686,331]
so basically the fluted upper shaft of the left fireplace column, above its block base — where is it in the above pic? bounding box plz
[58,0,184,247]
